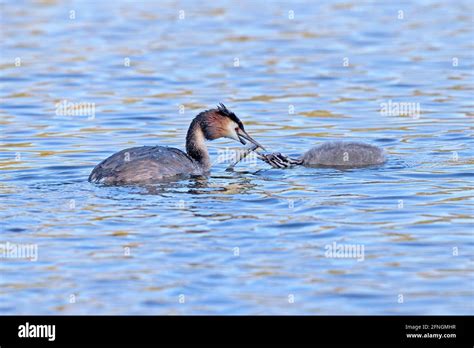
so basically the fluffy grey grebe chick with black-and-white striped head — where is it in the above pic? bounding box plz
[259,141,386,168]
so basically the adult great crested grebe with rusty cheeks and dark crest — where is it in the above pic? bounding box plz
[89,104,264,184]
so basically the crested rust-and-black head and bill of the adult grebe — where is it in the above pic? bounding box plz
[201,103,265,150]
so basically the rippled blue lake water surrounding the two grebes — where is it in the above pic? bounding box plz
[0,0,474,314]
